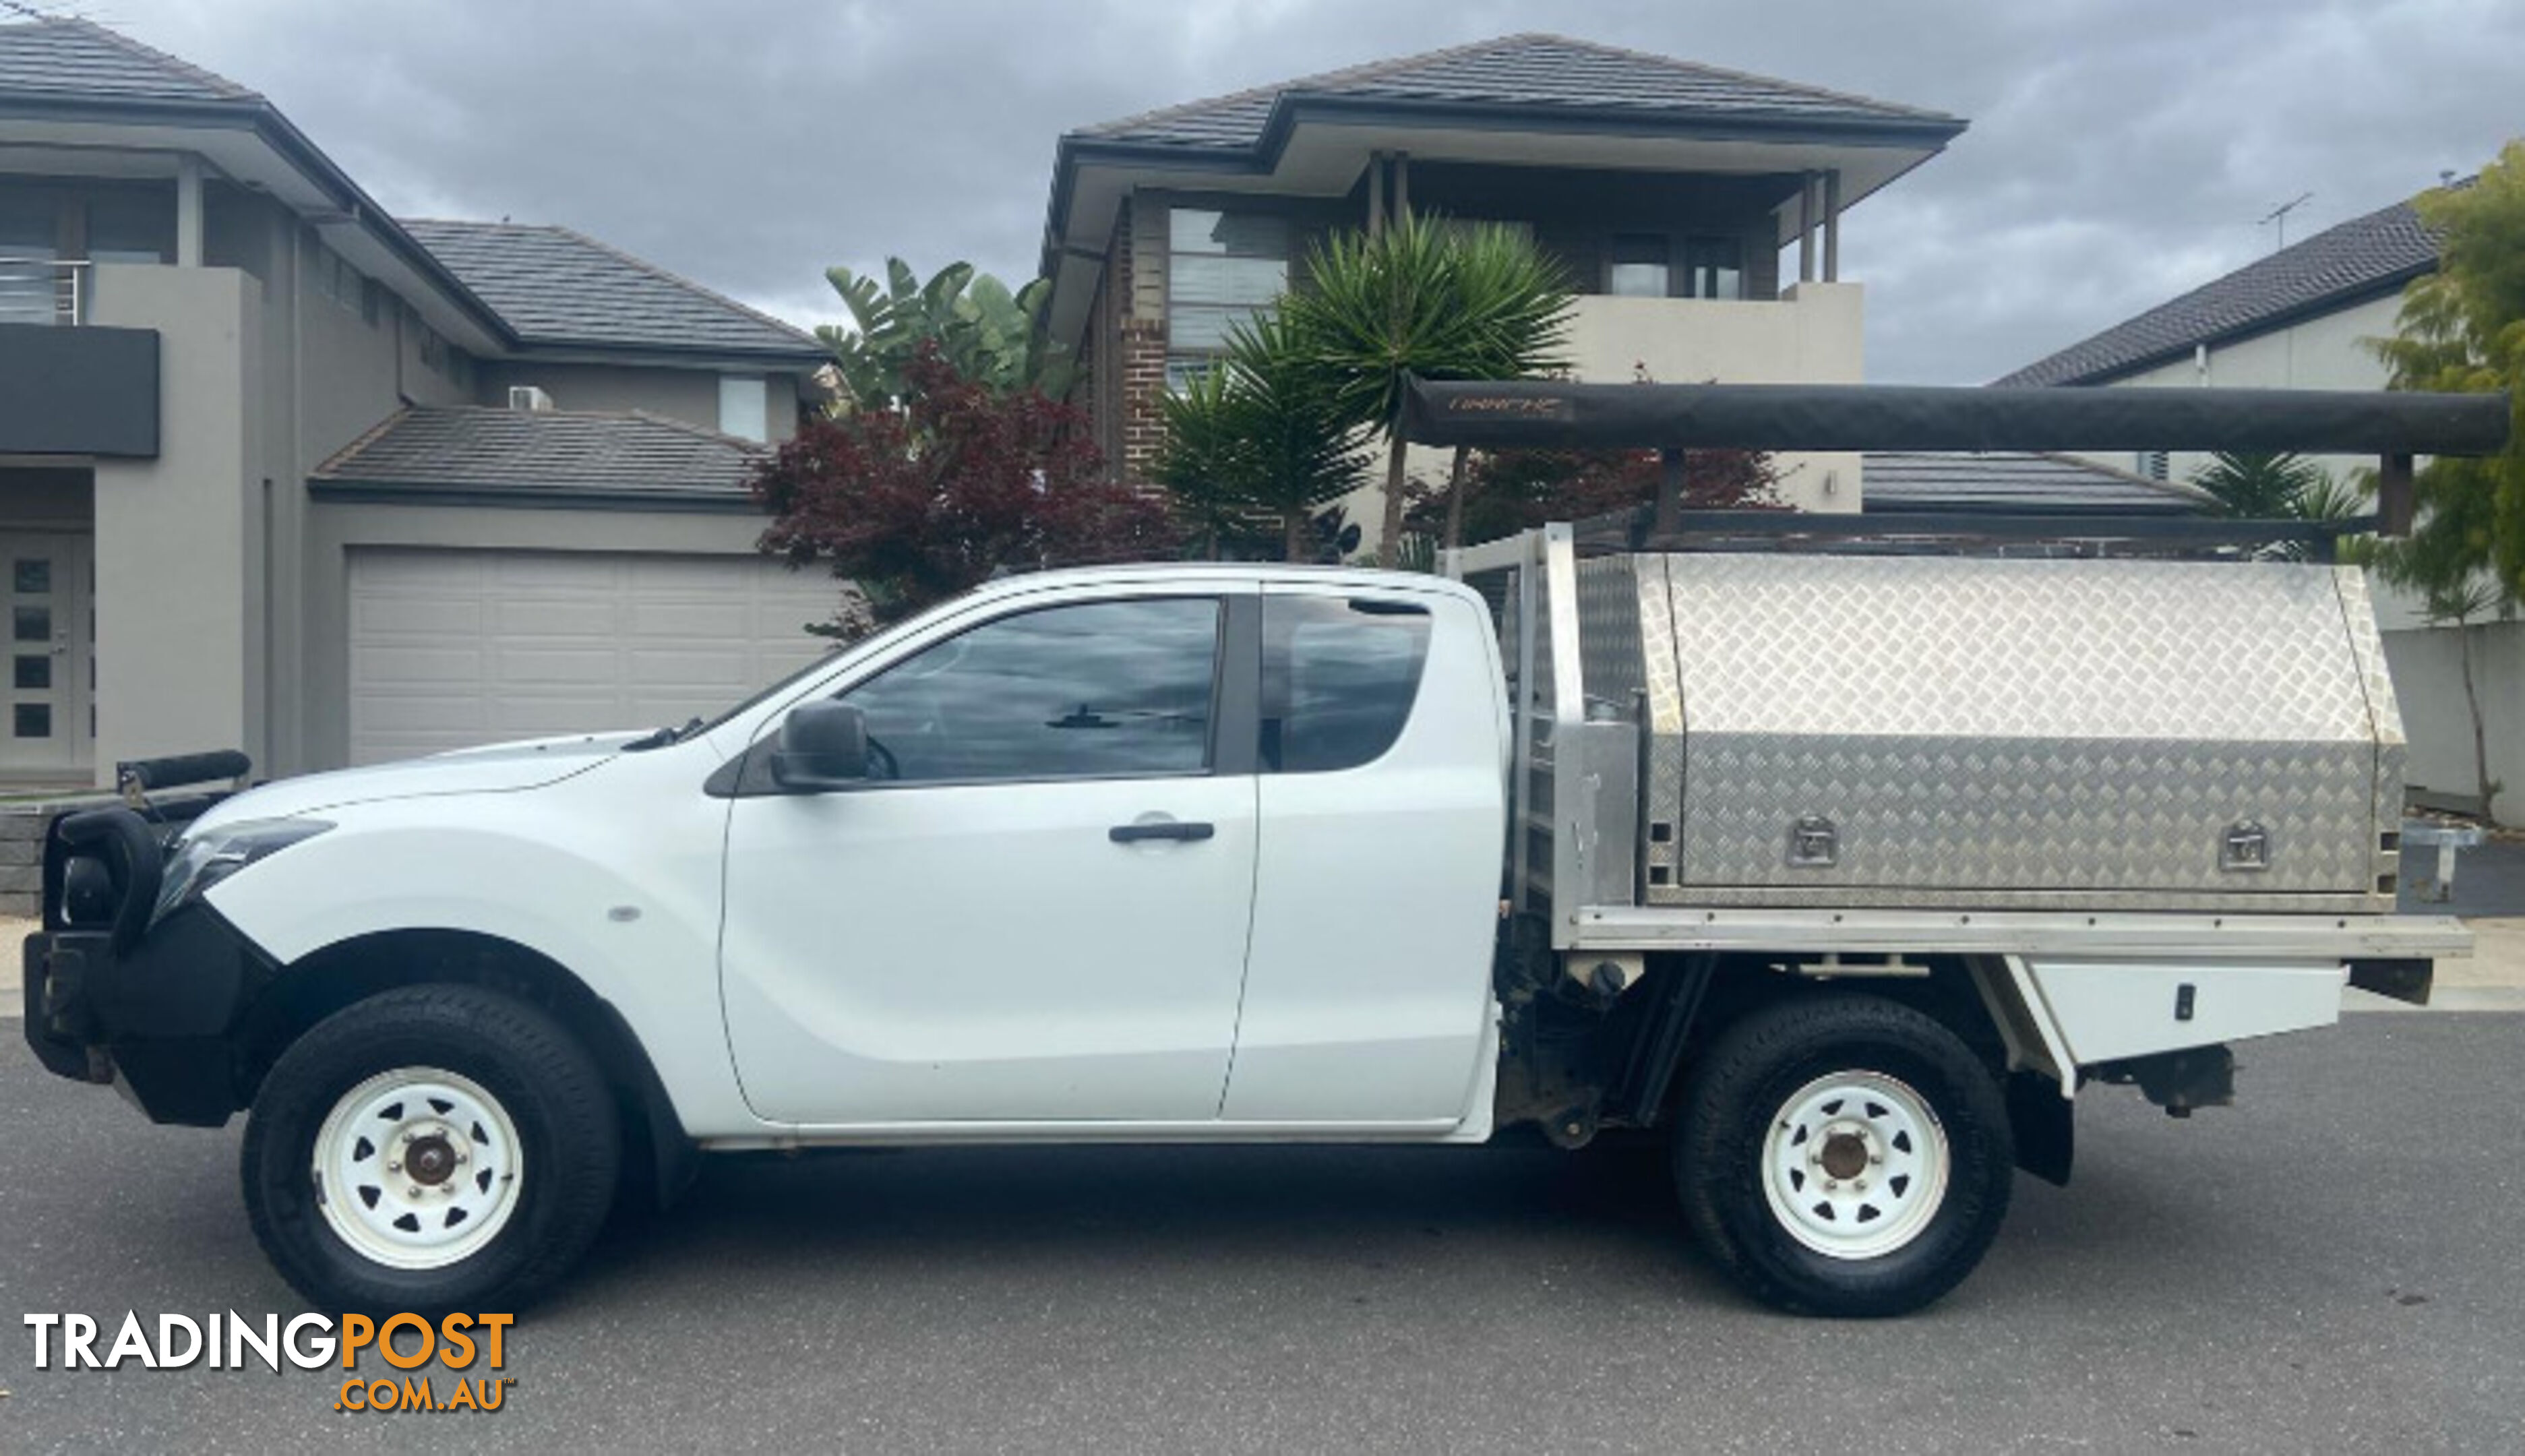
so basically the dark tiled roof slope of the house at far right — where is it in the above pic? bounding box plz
[1997,202,2437,384]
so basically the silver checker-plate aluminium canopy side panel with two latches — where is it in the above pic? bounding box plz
[1646,555,2381,911]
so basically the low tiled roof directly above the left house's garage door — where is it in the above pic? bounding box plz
[313,406,762,510]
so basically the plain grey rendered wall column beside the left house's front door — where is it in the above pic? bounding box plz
[91,265,268,782]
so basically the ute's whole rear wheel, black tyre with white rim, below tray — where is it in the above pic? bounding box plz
[1674,994,2015,1317]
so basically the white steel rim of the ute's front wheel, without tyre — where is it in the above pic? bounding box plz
[313,1068,525,1269]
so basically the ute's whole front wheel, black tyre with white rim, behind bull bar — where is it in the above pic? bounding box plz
[243,984,621,1312]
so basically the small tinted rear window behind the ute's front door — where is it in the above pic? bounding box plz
[1262,595,1429,775]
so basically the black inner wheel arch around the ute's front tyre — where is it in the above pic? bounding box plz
[233,929,697,1206]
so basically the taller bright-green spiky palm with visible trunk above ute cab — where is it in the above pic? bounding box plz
[1280,214,1571,566]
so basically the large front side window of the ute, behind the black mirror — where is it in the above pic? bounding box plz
[841,598,1219,782]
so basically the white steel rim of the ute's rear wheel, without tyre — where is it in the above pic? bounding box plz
[1763,1070,1954,1259]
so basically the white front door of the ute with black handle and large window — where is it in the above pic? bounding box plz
[720,590,1255,1126]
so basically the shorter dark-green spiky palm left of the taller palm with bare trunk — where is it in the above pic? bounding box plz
[1157,315,1368,560]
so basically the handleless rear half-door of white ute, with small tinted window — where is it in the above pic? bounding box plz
[1225,583,1507,1128]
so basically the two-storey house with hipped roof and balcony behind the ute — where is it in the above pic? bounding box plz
[1043,35,1964,527]
